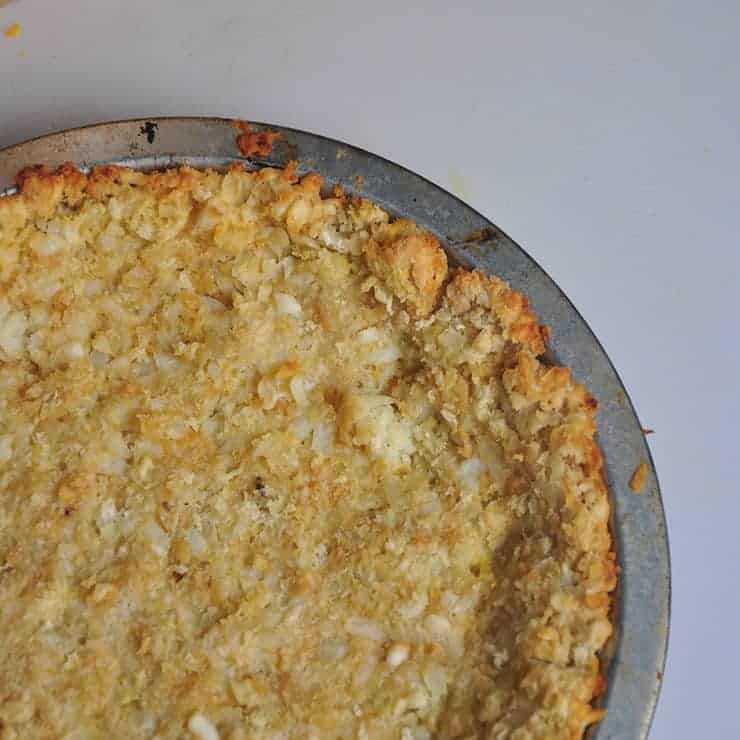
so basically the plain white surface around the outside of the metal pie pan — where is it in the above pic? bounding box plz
[0,0,740,740]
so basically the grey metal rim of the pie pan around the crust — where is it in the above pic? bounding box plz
[0,117,671,740]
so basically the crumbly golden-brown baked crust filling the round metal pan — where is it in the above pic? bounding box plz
[0,166,616,740]
